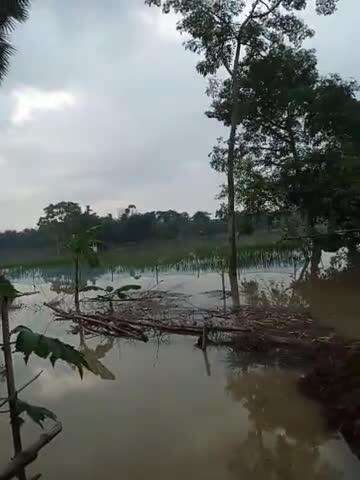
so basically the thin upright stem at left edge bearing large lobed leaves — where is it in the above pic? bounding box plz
[1,298,26,480]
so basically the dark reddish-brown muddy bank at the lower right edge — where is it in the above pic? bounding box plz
[300,343,360,458]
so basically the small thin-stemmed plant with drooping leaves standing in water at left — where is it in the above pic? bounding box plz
[67,226,99,312]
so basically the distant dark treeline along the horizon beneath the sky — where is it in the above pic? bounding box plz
[0,202,284,251]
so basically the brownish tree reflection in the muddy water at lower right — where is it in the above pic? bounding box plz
[226,369,343,480]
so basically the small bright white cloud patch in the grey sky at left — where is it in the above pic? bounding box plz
[11,87,76,126]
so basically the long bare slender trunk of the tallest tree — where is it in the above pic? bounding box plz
[227,38,241,310]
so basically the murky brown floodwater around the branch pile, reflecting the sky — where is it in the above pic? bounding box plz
[0,266,360,480]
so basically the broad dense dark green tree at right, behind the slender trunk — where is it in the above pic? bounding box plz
[211,45,360,271]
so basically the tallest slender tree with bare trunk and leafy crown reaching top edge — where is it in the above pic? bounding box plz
[146,0,338,308]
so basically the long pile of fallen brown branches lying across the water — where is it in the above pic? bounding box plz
[46,302,352,357]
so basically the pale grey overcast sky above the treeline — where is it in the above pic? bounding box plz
[0,0,360,229]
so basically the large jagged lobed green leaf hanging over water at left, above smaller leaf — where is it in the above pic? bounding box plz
[13,325,91,378]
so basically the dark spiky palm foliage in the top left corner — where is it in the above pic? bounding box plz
[0,0,30,83]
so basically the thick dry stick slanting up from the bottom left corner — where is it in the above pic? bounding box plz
[0,423,62,480]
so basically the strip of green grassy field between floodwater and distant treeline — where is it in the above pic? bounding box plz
[0,236,298,271]
